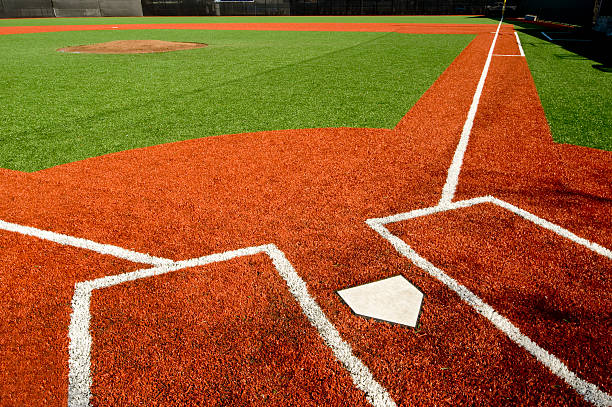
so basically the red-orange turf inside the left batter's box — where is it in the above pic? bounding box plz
[91,255,368,406]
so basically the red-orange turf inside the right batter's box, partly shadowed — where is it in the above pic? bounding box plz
[389,204,612,392]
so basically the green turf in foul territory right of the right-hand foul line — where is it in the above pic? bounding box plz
[519,27,612,151]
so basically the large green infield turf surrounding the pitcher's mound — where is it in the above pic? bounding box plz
[0,30,474,171]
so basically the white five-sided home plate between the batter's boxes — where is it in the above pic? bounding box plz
[338,276,423,327]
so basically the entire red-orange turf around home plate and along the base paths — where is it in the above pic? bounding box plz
[0,20,612,406]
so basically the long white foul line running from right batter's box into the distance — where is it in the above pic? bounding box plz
[439,19,503,205]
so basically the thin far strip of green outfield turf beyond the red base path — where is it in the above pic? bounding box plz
[0,16,504,27]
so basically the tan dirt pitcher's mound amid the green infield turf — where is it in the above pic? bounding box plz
[58,40,208,54]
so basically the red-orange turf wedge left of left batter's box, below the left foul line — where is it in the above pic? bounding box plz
[0,231,147,406]
